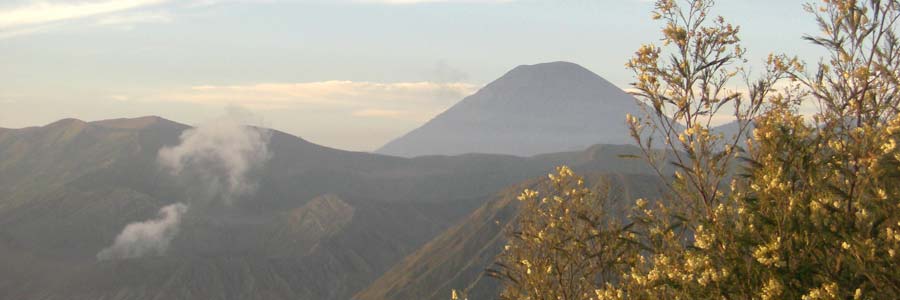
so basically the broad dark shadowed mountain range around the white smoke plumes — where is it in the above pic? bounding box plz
[0,117,650,300]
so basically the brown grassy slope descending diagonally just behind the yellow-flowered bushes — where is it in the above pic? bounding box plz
[354,173,663,300]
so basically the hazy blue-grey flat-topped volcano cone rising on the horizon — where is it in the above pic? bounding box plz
[376,62,642,157]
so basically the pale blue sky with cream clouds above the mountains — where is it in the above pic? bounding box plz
[0,0,820,151]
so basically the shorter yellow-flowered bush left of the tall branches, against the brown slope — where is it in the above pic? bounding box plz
[488,166,640,300]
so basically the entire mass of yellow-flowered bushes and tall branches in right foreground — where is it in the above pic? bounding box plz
[486,0,900,299]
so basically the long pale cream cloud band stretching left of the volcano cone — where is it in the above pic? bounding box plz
[152,81,480,119]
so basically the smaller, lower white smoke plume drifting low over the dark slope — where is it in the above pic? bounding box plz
[97,203,188,260]
